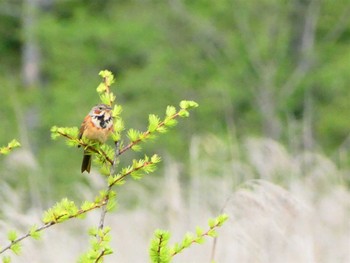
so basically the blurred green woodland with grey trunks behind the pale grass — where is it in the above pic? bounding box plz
[0,0,350,202]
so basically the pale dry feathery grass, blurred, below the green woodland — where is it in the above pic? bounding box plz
[0,136,350,263]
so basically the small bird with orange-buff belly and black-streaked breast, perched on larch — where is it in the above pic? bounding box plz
[78,104,113,173]
